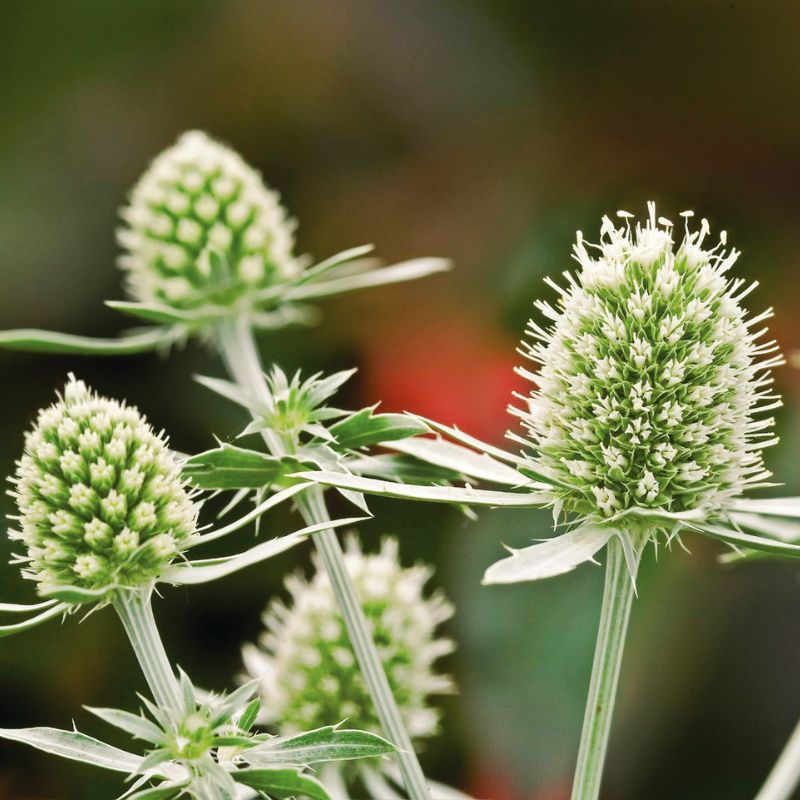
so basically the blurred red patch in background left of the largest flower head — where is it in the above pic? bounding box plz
[363,317,530,442]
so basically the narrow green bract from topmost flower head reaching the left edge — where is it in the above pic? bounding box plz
[0,327,178,356]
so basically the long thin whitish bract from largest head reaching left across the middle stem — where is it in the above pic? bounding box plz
[290,471,550,508]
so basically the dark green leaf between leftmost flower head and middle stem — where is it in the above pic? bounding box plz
[183,444,292,489]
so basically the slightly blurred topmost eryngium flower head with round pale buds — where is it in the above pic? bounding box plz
[118,131,301,309]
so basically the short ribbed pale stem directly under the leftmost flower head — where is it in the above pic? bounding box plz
[114,585,183,720]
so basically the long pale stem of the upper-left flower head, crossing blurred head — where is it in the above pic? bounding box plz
[218,317,430,800]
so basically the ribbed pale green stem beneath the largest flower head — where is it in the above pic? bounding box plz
[572,537,643,800]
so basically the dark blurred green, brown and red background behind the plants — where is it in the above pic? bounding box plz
[0,0,800,800]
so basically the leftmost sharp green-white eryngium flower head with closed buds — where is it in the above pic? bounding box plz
[11,376,197,592]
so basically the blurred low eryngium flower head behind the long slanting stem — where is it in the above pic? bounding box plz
[244,538,453,737]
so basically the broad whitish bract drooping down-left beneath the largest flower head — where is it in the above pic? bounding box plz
[483,525,617,584]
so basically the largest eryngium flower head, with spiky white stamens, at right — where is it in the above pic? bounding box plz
[512,203,782,518]
